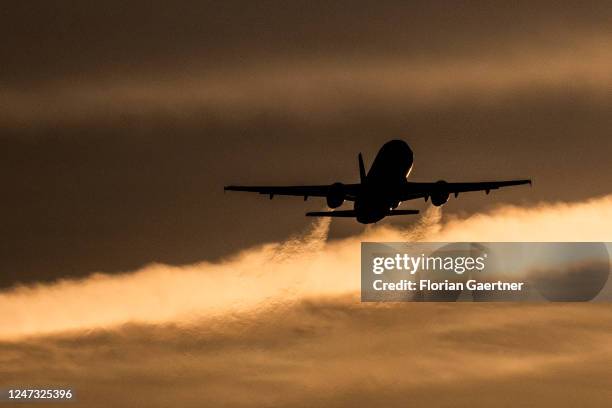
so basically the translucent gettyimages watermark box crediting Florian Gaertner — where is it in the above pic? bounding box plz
[361,242,612,302]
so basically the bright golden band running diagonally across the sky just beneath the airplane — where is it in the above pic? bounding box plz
[0,195,612,339]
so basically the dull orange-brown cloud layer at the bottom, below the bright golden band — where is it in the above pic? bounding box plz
[0,295,612,407]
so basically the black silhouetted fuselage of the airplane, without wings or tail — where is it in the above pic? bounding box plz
[354,140,414,224]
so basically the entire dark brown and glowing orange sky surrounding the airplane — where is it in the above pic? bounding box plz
[0,1,612,406]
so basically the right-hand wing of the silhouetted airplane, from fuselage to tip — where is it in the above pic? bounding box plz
[400,180,531,201]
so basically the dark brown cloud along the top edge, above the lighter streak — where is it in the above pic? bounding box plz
[0,0,611,86]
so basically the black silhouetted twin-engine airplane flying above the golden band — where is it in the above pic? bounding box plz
[224,140,531,224]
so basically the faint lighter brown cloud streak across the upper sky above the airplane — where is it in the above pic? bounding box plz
[0,34,612,128]
